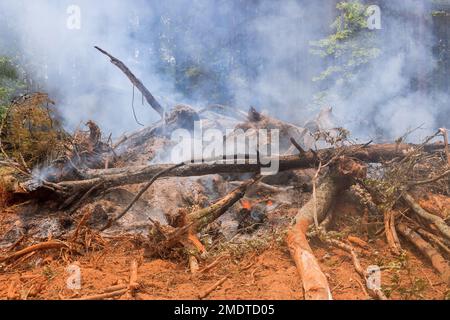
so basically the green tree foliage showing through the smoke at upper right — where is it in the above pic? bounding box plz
[311,1,381,83]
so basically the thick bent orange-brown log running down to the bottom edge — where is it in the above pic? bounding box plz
[287,177,339,300]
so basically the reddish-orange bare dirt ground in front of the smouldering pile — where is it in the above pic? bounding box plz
[0,196,449,300]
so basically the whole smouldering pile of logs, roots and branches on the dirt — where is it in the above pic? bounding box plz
[0,48,450,299]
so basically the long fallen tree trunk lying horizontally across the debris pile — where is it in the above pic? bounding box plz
[21,144,444,194]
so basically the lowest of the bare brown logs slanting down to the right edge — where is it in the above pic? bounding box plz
[397,223,450,285]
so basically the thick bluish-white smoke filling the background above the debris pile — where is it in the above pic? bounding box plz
[0,0,449,139]
